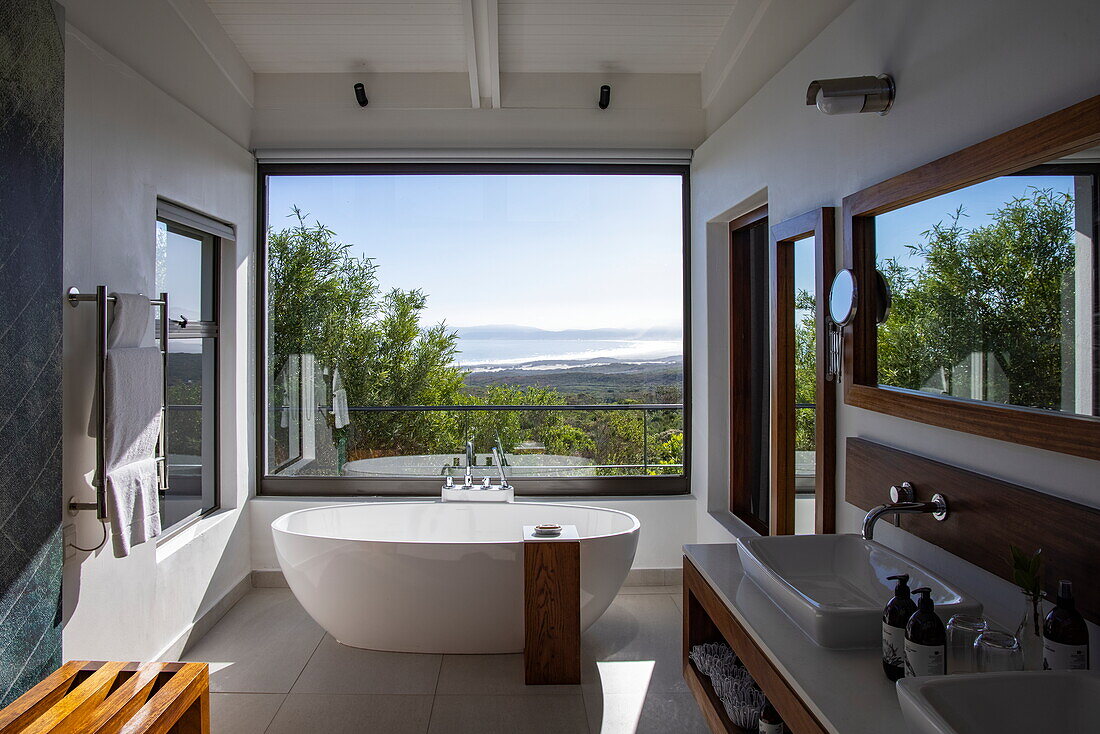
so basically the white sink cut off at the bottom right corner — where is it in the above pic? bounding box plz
[898,670,1100,734]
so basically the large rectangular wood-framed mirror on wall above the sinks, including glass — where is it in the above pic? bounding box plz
[844,97,1100,459]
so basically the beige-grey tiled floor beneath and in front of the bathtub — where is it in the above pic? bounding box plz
[186,587,707,734]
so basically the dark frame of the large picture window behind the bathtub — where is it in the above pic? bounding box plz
[255,158,692,497]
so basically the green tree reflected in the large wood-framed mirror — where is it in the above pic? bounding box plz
[878,188,1075,410]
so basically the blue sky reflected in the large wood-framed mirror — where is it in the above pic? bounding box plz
[875,176,1074,267]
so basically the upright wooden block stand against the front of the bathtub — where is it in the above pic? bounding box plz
[524,540,581,686]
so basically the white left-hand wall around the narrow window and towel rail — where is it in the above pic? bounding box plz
[57,24,255,660]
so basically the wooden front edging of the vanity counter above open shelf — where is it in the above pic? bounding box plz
[684,557,826,734]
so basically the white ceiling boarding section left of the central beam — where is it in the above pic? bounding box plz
[207,0,466,74]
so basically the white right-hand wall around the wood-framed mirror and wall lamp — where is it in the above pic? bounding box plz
[692,0,1100,625]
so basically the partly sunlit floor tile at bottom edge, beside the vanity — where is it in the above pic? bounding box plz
[584,692,710,734]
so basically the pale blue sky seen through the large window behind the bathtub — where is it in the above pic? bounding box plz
[268,175,682,329]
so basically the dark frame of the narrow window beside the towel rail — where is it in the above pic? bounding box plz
[154,198,222,533]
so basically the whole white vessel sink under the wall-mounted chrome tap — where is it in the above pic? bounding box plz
[737,535,981,648]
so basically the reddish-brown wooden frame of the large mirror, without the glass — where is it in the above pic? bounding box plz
[844,96,1100,460]
